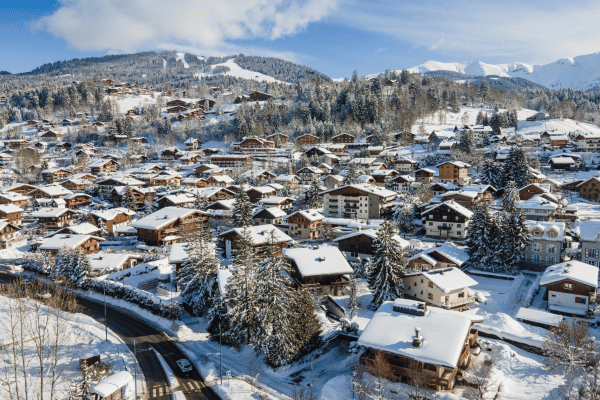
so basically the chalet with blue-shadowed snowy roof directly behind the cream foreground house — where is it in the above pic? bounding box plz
[407,242,469,272]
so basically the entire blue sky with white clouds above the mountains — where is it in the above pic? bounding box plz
[0,0,600,78]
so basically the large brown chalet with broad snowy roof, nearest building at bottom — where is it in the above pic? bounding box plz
[358,299,483,391]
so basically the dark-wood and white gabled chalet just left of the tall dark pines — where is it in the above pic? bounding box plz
[421,200,473,240]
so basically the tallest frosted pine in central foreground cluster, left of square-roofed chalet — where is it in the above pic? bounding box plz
[254,231,300,366]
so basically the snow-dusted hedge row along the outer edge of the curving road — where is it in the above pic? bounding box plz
[85,280,180,319]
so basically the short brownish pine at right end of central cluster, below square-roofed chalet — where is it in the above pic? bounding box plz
[290,286,321,355]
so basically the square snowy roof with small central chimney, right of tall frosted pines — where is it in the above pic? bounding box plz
[283,245,354,277]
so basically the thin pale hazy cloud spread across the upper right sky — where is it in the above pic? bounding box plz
[333,0,600,63]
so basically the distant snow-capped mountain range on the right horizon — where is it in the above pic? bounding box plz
[400,53,600,90]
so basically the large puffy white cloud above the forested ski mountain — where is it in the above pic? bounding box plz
[36,0,340,52]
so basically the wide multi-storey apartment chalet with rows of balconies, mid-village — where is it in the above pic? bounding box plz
[321,185,396,218]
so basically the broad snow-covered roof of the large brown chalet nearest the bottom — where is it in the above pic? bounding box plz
[358,299,475,368]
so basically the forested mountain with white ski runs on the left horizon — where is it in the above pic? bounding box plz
[19,51,331,83]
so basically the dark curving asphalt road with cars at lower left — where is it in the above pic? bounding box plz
[0,272,220,400]
